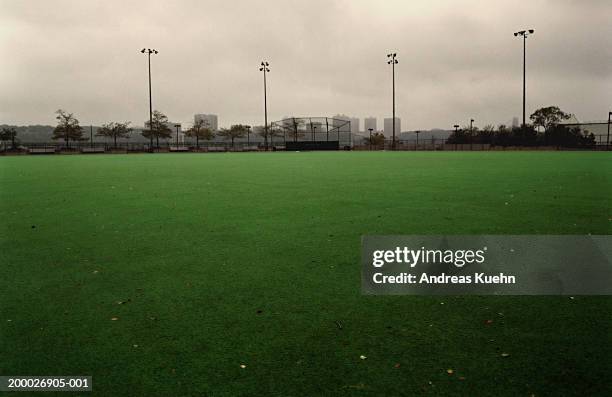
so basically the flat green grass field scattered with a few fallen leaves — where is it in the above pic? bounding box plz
[0,152,612,396]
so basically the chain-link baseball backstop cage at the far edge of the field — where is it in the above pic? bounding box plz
[269,117,353,150]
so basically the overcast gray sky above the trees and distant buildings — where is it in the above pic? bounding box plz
[0,0,612,130]
